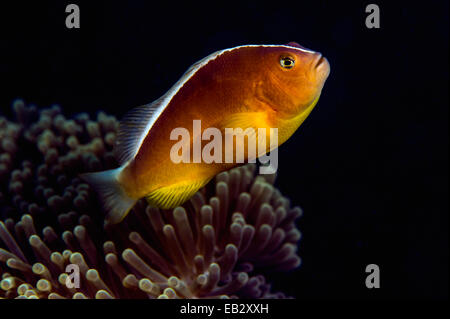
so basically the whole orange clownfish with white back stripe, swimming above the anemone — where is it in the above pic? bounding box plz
[81,42,330,223]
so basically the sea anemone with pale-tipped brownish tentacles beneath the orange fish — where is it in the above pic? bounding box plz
[0,100,301,299]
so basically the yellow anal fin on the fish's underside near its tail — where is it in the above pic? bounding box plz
[146,177,211,209]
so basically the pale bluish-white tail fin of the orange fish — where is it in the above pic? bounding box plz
[80,167,137,225]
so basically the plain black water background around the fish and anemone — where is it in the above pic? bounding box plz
[0,0,449,299]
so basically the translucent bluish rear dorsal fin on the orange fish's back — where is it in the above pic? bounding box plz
[114,97,165,165]
